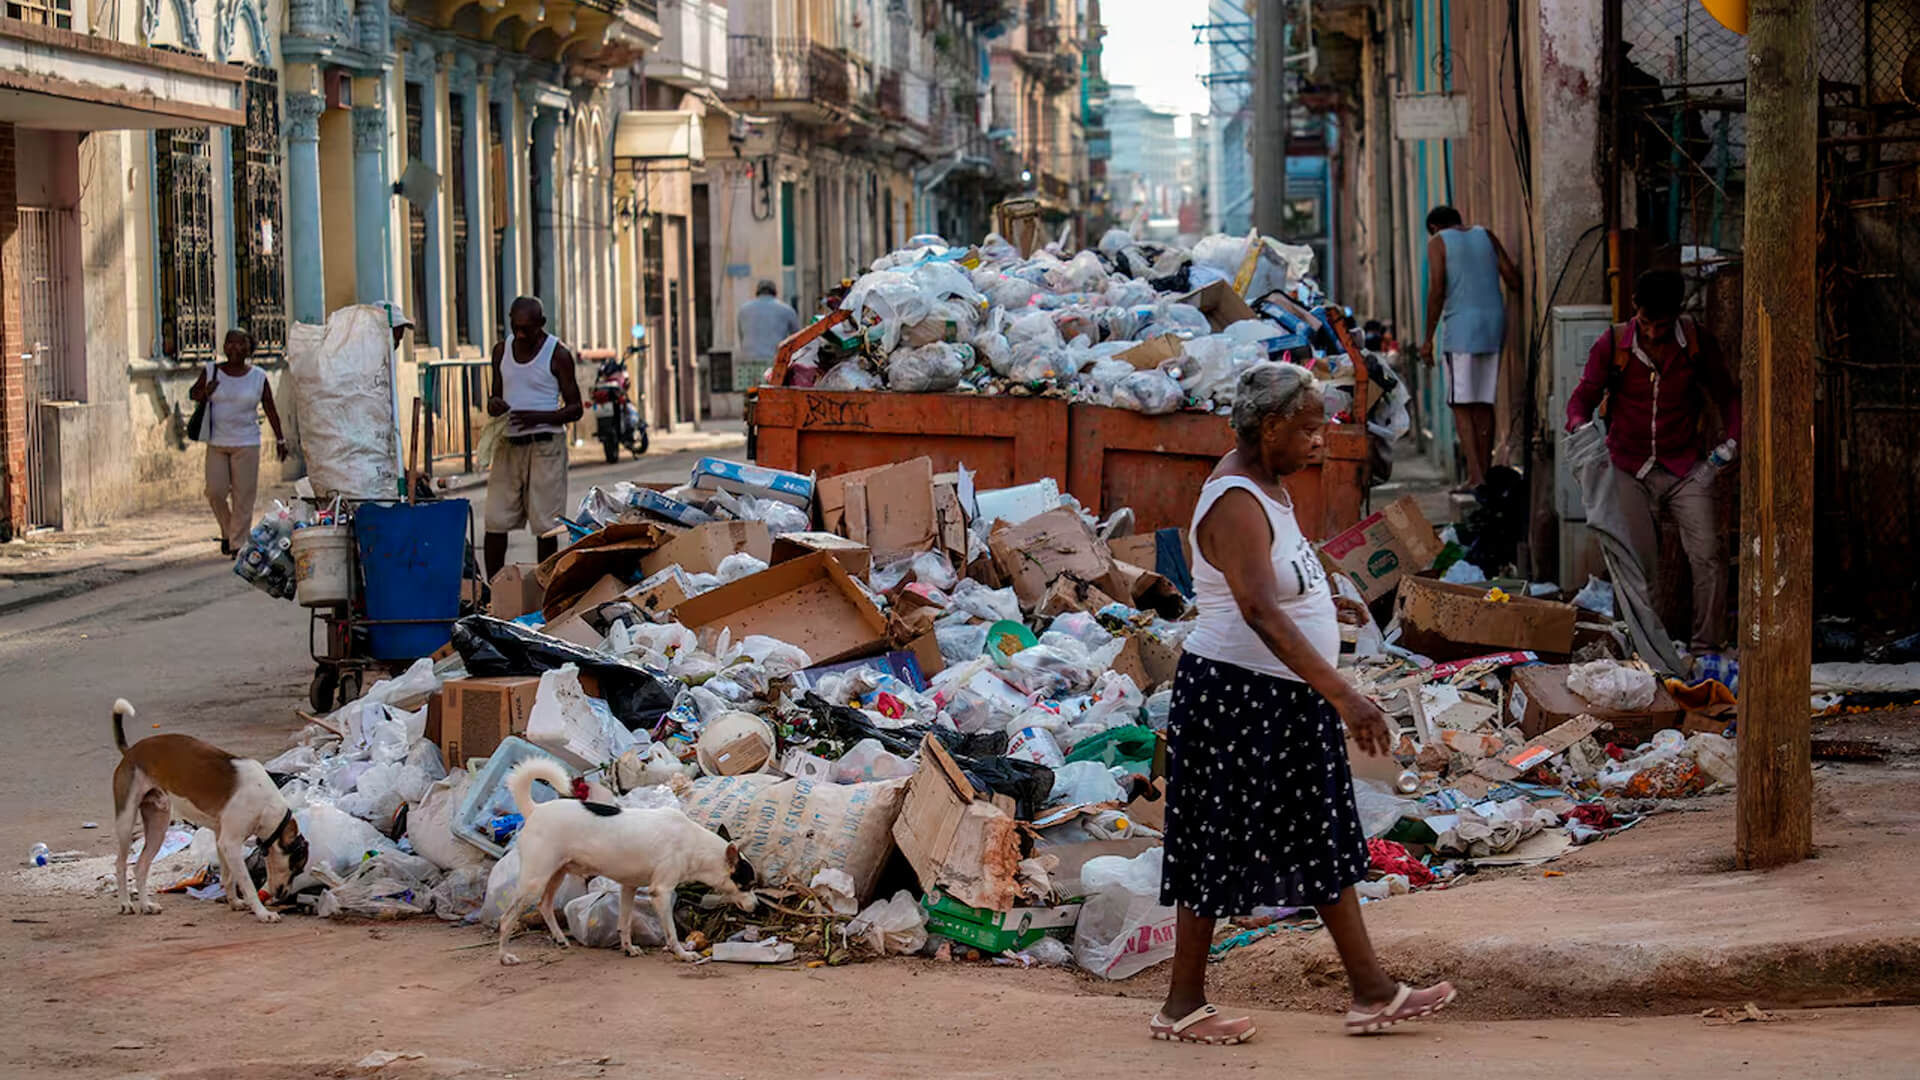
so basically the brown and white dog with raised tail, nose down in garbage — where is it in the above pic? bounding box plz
[113,698,307,922]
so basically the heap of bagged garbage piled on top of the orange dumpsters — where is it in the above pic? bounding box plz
[783,229,1411,440]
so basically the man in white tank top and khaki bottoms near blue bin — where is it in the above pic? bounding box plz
[486,296,580,580]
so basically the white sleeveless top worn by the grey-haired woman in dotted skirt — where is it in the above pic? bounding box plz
[1187,477,1340,682]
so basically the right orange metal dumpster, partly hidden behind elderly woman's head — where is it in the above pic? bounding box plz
[1068,405,1367,540]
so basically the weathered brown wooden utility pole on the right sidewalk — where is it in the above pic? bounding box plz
[1734,0,1820,869]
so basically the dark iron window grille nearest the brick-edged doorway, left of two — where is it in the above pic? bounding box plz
[154,127,219,361]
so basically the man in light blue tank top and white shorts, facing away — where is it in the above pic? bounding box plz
[1419,206,1521,494]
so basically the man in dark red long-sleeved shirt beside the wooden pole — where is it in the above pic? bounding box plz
[1567,271,1740,653]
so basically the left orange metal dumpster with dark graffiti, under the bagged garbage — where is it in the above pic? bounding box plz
[753,386,1068,488]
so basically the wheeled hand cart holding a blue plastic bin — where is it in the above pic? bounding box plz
[305,498,484,713]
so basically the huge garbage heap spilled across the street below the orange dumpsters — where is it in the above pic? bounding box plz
[97,445,1758,978]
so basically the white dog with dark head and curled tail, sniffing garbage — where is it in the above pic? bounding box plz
[499,759,756,965]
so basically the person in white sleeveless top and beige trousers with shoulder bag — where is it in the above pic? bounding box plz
[186,331,286,555]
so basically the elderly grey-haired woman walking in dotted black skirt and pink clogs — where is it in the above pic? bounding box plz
[1150,363,1453,1043]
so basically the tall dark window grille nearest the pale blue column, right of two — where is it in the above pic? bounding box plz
[232,67,286,357]
